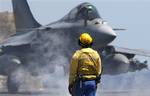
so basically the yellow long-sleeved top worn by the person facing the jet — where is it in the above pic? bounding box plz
[69,48,102,84]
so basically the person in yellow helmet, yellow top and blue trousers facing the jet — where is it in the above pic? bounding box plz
[68,33,102,96]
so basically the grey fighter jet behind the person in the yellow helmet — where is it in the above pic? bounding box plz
[0,0,150,92]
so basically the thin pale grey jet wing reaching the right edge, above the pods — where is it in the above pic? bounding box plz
[113,46,150,57]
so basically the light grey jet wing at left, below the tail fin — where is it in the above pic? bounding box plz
[0,26,52,48]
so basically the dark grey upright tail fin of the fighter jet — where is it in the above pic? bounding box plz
[12,0,41,31]
